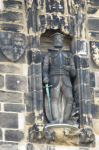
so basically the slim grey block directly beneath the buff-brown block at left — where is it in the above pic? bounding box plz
[4,104,25,112]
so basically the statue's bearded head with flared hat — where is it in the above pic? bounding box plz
[51,32,65,48]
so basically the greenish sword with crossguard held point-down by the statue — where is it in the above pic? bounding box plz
[45,84,52,121]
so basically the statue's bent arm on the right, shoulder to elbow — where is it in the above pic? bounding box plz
[69,54,76,77]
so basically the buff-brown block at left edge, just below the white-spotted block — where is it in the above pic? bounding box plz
[0,91,22,103]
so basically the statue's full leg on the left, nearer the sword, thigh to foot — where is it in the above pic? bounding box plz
[50,85,60,122]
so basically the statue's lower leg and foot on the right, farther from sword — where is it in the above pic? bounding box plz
[64,98,73,122]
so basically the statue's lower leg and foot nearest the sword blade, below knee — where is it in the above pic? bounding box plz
[51,101,59,123]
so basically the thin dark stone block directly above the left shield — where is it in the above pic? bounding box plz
[0,23,23,32]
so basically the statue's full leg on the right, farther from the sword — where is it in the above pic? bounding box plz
[63,87,73,122]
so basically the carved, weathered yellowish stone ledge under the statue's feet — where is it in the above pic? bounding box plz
[29,123,95,147]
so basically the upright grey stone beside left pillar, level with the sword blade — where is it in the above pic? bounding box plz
[24,92,33,112]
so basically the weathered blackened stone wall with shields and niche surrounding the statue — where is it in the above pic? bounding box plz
[0,0,99,150]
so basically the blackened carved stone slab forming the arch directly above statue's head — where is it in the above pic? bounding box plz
[39,13,76,38]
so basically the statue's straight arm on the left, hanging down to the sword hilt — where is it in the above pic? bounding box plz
[43,53,49,84]
